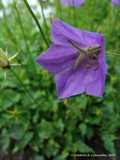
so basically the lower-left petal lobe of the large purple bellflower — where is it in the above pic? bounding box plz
[55,66,86,99]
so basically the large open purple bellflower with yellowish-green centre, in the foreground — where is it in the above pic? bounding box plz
[37,19,107,99]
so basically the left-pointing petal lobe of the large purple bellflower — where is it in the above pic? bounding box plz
[37,45,77,73]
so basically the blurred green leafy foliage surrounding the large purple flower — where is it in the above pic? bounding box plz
[0,0,120,160]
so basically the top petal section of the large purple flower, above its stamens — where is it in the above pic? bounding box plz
[52,19,103,47]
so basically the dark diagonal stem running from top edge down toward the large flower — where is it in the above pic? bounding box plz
[23,0,49,47]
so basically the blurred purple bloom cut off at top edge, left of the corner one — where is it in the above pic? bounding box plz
[61,0,85,7]
